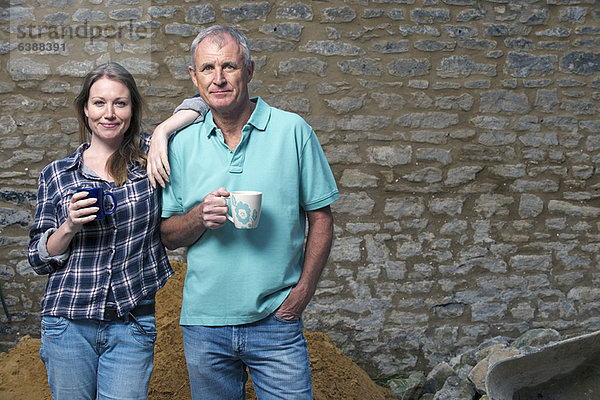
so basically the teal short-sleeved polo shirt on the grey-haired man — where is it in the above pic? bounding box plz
[162,98,339,326]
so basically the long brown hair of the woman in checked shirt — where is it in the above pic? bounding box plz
[73,62,146,186]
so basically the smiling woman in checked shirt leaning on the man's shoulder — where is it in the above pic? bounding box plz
[29,63,206,400]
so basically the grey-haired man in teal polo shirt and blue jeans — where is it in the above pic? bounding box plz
[161,26,339,399]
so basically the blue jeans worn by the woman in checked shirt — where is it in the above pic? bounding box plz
[40,315,156,400]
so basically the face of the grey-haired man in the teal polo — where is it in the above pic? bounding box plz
[189,34,254,113]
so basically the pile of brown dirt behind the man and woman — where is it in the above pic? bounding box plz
[0,262,395,400]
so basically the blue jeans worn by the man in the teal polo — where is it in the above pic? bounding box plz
[182,315,313,400]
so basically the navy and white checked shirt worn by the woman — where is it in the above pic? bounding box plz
[28,133,173,320]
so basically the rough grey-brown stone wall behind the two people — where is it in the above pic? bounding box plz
[0,0,600,376]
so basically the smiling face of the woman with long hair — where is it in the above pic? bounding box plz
[84,77,132,145]
